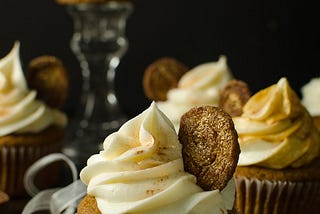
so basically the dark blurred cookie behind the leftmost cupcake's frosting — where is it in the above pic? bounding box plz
[26,55,69,108]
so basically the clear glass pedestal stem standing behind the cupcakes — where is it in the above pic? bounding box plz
[65,1,133,169]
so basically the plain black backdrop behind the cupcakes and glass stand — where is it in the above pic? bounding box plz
[0,0,320,120]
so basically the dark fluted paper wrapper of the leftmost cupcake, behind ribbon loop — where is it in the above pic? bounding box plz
[0,143,61,197]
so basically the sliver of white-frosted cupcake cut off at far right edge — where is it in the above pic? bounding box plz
[301,77,320,131]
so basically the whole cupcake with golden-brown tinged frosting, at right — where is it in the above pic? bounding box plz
[233,78,320,214]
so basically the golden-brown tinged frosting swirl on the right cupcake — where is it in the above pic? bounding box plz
[233,78,320,169]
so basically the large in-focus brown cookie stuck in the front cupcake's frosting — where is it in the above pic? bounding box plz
[179,106,240,190]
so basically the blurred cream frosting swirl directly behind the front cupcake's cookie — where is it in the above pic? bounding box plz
[157,56,232,130]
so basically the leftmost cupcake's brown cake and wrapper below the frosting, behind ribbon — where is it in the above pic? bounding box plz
[0,126,64,199]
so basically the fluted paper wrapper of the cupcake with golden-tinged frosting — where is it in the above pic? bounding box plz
[235,176,320,214]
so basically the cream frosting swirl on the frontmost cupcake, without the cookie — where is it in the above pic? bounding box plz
[80,102,235,213]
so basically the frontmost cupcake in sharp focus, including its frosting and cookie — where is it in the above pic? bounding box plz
[77,102,239,214]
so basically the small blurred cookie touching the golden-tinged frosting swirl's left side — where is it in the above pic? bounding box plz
[219,80,251,117]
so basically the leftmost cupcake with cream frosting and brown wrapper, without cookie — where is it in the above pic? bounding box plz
[0,42,67,200]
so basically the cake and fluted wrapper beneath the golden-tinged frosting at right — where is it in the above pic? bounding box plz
[234,160,320,214]
